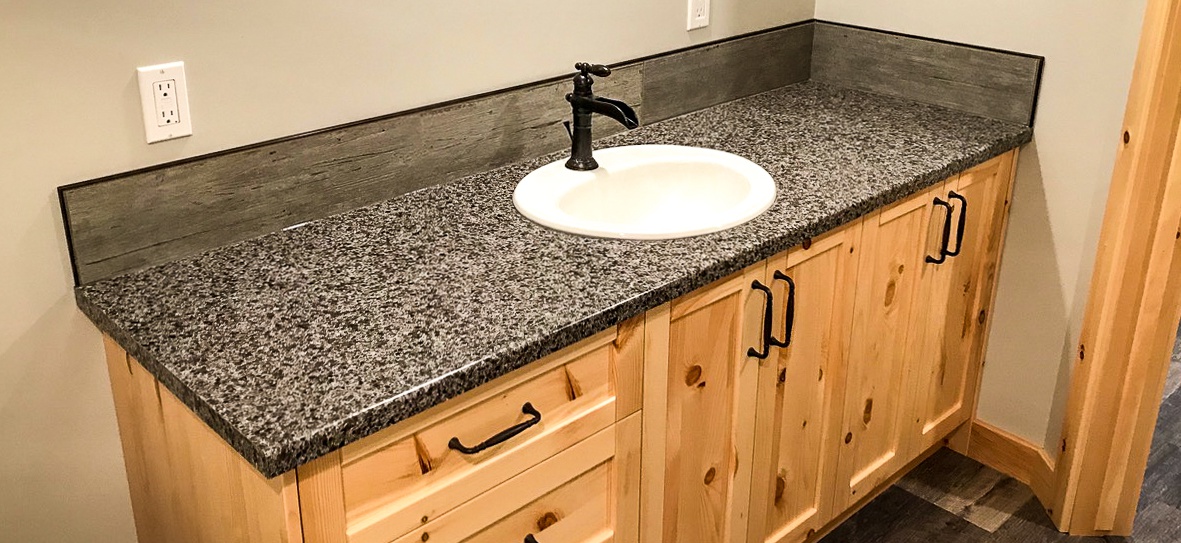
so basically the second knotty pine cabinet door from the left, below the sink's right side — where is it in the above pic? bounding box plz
[746,222,861,543]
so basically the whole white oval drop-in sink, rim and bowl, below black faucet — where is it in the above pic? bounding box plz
[513,145,775,240]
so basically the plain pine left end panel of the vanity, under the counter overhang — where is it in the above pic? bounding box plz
[104,336,304,543]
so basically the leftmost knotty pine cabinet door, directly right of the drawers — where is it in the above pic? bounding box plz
[640,264,766,543]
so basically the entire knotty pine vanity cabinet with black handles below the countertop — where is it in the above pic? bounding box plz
[99,151,1016,543]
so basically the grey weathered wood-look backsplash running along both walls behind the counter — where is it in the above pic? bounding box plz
[59,21,1040,284]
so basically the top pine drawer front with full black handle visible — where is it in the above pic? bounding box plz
[341,335,618,543]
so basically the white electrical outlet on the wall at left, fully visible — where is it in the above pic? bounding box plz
[136,63,193,143]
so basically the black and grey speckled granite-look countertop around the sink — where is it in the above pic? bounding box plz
[77,81,1031,477]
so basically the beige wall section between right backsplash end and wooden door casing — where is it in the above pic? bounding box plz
[816,0,1144,451]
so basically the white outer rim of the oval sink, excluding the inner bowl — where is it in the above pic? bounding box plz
[513,144,777,240]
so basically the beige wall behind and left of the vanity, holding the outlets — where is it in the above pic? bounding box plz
[0,0,814,543]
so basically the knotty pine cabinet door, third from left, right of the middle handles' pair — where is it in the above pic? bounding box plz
[834,184,942,511]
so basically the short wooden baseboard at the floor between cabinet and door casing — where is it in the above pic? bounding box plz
[966,420,1056,506]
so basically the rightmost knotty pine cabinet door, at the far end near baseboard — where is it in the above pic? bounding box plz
[907,155,1011,457]
